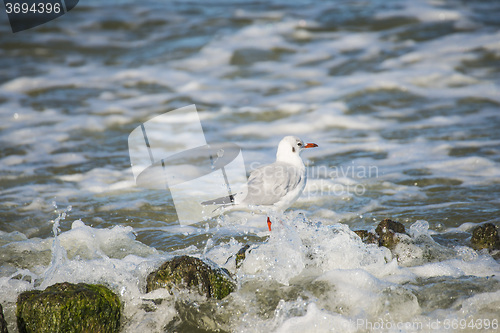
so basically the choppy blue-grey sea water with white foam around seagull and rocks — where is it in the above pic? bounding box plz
[0,0,500,332]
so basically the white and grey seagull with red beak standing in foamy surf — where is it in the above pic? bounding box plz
[202,136,318,231]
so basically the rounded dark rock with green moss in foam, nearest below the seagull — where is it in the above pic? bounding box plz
[146,256,236,299]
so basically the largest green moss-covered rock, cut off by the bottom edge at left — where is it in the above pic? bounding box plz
[16,282,121,333]
